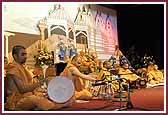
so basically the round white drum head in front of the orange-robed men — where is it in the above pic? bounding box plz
[47,76,74,103]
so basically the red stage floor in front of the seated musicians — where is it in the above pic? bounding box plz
[56,86,164,111]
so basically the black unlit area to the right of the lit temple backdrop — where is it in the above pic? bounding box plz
[102,4,164,69]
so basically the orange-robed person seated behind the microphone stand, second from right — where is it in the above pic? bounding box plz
[118,62,140,82]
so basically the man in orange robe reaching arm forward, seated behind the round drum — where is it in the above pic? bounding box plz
[61,55,97,100]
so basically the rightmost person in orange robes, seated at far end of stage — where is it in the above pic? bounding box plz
[147,65,164,84]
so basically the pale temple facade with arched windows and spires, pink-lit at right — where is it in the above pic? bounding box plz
[5,4,119,67]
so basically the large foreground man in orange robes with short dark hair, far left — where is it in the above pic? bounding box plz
[5,45,72,110]
